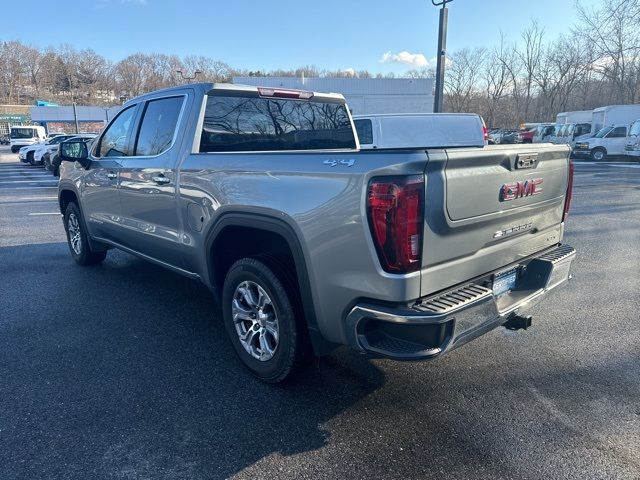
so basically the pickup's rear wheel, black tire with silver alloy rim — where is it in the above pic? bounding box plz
[222,258,311,383]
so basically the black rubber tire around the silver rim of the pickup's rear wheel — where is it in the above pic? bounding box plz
[222,258,312,383]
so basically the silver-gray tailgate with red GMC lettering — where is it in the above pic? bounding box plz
[421,144,569,295]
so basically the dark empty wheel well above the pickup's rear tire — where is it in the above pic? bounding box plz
[209,226,300,293]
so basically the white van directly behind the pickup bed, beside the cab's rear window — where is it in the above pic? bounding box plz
[353,113,487,150]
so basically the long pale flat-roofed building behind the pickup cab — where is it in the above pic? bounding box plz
[233,77,434,115]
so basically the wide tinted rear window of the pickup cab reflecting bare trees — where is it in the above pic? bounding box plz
[200,94,356,153]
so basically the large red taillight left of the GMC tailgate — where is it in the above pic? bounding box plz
[367,175,424,273]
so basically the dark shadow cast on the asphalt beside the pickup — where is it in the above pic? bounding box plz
[0,243,383,478]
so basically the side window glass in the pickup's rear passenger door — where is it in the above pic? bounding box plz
[134,97,184,156]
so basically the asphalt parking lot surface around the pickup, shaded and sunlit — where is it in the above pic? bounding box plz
[0,149,640,479]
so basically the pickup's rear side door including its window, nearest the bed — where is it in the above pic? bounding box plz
[119,95,187,268]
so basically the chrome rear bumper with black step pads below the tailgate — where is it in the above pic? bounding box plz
[346,245,576,360]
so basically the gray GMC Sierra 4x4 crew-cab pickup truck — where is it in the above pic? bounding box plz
[59,84,575,382]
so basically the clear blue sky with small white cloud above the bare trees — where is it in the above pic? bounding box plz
[0,0,603,74]
